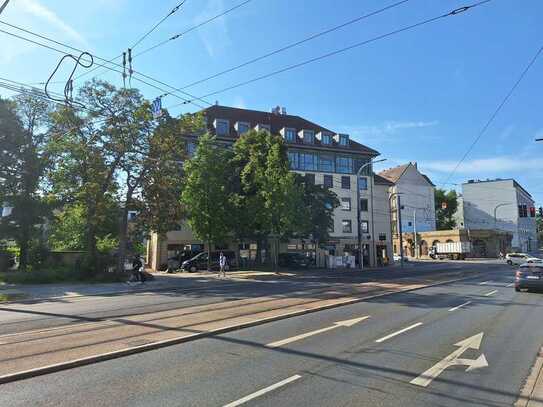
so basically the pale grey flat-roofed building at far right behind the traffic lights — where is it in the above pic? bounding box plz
[458,179,537,252]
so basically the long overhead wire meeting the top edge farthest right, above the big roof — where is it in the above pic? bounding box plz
[167,0,492,109]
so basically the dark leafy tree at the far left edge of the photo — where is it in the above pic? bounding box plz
[0,94,50,270]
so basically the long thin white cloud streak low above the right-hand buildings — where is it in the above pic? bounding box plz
[419,156,543,175]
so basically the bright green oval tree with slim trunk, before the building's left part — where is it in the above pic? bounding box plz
[181,134,233,269]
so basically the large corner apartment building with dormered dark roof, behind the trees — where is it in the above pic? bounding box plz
[148,105,392,268]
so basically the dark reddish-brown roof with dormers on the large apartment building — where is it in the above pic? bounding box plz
[203,105,379,156]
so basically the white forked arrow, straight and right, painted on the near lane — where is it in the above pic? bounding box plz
[409,332,488,387]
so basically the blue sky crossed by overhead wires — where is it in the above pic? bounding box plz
[0,0,543,206]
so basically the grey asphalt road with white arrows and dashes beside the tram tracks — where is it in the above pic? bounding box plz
[0,265,543,406]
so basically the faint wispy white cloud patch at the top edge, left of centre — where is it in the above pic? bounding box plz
[194,0,231,57]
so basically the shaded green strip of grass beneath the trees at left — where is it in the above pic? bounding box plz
[0,268,128,284]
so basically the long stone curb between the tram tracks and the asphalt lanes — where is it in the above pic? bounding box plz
[0,276,477,384]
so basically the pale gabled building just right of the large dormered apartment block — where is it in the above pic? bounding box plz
[379,162,436,249]
